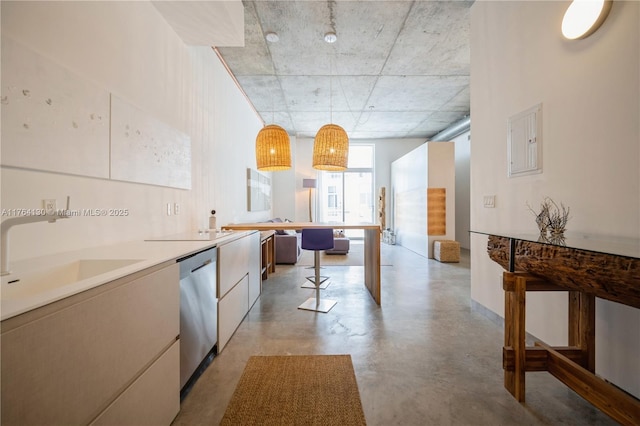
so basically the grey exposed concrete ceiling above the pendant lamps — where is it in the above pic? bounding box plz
[216,0,473,140]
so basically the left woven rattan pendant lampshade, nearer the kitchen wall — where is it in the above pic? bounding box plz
[256,124,291,172]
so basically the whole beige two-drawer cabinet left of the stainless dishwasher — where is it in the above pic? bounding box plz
[1,262,180,425]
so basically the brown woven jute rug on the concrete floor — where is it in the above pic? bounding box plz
[220,355,366,426]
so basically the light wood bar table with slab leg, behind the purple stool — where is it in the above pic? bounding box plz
[222,222,381,305]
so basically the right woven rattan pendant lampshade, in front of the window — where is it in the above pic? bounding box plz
[313,124,349,172]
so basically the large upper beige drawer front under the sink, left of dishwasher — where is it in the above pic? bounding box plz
[0,263,180,426]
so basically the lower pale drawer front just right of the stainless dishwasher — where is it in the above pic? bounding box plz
[218,275,249,352]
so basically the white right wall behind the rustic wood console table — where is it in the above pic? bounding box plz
[471,1,640,396]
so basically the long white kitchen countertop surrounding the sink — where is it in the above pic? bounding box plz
[0,231,251,320]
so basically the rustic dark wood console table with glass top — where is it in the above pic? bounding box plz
[476,232,640,425]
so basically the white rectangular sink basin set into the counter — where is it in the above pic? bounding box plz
[2,259,142,300]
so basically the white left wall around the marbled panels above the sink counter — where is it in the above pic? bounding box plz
[0,1,270,259]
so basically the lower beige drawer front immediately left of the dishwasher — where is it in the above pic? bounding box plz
[91,340,180,426]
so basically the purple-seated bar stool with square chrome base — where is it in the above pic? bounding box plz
[298,228,337,313]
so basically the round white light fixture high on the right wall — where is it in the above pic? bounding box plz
[562,0,612,40]
